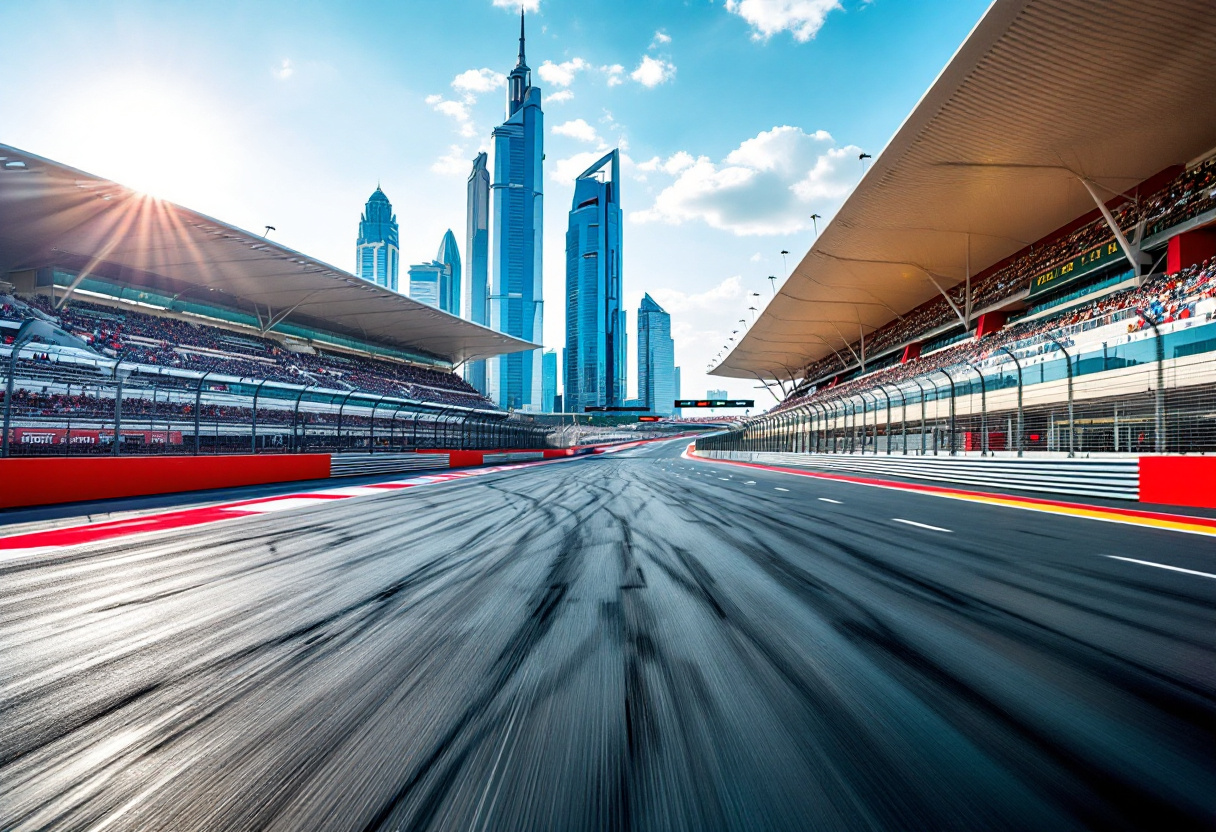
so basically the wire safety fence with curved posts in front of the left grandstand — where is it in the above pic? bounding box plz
[0,344,551,456]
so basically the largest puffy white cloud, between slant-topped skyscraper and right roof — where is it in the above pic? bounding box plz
[630,125,860,236]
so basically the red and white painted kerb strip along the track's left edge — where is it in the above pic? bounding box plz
[0,456,581,557]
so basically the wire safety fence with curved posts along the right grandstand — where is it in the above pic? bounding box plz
[698,313,1216,456]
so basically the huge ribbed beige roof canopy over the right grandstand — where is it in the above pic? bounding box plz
[711,0,1216,380]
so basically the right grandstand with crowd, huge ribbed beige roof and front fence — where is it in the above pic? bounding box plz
[711,0,1216,454]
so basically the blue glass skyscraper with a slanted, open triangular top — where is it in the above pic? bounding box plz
[564,150,625,412]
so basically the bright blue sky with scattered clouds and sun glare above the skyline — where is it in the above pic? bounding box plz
[0,0,989,404]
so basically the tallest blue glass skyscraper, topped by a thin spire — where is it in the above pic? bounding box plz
[486,11,545,410]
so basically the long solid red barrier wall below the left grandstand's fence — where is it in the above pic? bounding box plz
[0,454,330,508]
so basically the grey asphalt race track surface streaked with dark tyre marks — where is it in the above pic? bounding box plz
[0,443,1216,832]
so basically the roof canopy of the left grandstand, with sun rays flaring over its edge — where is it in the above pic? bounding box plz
[0,145,536,364]
